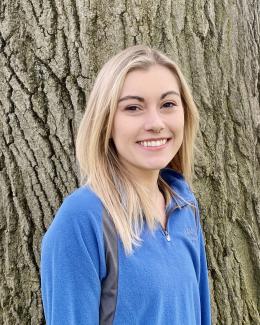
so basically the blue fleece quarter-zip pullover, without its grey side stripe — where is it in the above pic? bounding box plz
[41,169,211,325]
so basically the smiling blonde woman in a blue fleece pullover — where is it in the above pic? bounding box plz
[41,46,210,325]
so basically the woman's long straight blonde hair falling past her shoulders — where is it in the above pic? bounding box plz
[76,45,199,254]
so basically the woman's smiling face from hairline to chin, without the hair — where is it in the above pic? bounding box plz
[112,65,184,174]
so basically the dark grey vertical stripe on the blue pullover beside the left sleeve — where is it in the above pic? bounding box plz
[99,208,118,325]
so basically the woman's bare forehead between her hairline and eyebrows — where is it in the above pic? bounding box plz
[121,65,180,96]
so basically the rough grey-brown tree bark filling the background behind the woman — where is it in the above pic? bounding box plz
[0,0,260,325]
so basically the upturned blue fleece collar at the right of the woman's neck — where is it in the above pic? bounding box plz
[160,168,196,202]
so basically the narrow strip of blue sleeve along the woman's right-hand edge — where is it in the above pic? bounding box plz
[199,220,211,325]
